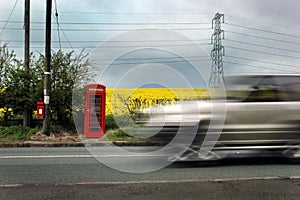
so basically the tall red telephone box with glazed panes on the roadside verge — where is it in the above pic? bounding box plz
[84,84,106,138]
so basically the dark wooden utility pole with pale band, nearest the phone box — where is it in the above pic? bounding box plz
[43,0,52,135]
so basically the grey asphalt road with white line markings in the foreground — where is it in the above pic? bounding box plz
[0,147,300,199]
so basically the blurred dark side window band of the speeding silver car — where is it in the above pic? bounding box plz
[225,75,300,102]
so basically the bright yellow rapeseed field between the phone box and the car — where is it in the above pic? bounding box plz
[106,88,210,115]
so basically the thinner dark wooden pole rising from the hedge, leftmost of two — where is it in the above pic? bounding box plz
[23,0,32,126]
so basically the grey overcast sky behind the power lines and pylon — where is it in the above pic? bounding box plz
[0,0,300,87]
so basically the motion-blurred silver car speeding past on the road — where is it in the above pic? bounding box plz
[140,74,300,160]
